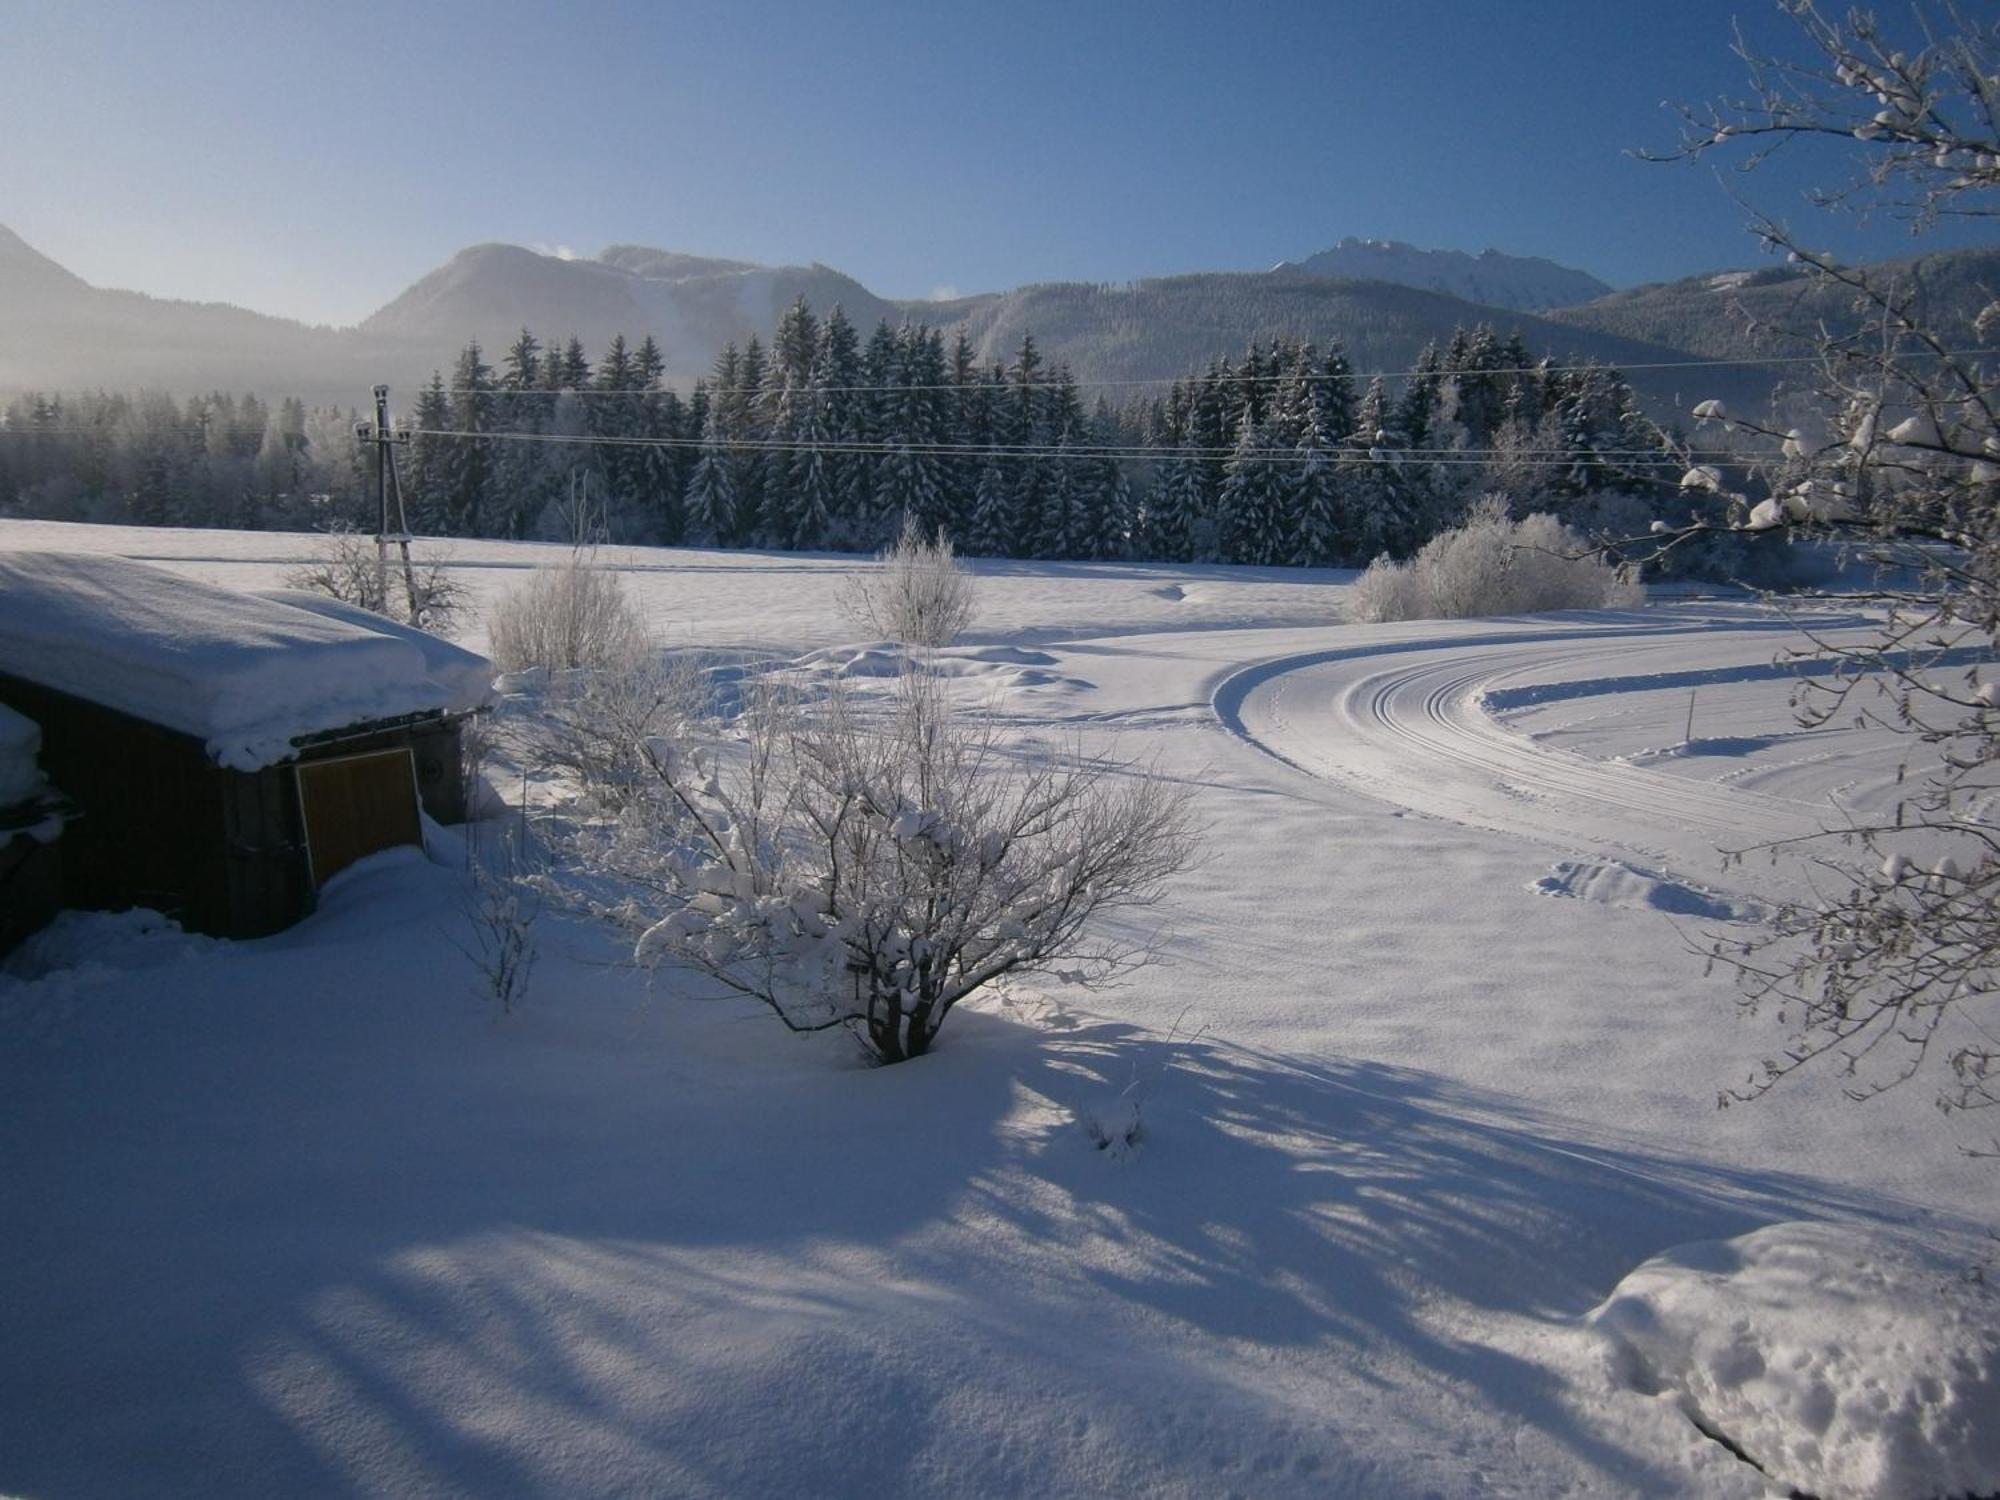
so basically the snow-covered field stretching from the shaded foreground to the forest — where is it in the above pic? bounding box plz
[0,522,2000,1500]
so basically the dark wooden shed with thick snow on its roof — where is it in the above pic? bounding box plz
[0,552,492,938]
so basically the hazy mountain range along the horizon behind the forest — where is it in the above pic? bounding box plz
[11,228,2000,418]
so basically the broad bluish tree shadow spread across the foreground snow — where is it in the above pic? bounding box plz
[0,980,1944,1496]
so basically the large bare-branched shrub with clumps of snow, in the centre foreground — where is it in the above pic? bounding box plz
[616,672,1196,1062]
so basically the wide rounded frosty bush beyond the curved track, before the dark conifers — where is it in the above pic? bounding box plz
[1348,496,1642,622]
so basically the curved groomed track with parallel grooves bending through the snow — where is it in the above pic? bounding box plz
[1212,610,1830,884]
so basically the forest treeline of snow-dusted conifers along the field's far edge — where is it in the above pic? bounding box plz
[0,300,1680,566]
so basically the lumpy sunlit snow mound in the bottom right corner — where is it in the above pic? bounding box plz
[1590,1224,2000,1500]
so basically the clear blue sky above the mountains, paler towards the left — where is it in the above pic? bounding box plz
[0,0,1992,322]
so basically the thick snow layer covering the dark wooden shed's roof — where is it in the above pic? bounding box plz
[0,552,484,770]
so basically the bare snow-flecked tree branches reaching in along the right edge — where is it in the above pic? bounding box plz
[1674,0,2000,1154]
